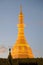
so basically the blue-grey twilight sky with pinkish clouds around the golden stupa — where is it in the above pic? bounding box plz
[0,0,43,57]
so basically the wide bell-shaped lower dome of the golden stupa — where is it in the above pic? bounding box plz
[11,39,34,58]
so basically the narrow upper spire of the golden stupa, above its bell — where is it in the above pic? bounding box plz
[17,6,24,38]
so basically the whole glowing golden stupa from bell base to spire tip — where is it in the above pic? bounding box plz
[11,7,34,59]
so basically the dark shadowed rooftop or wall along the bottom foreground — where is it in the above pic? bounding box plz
[0,57,43,65]
